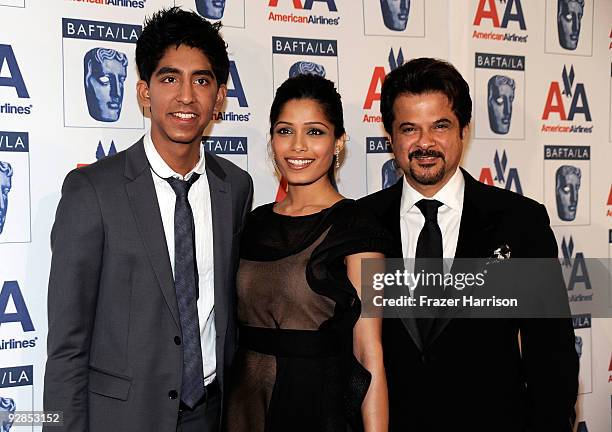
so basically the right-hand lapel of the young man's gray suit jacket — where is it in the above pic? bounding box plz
[206,153,234,358]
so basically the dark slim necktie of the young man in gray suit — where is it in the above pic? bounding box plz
[166,173,204,408]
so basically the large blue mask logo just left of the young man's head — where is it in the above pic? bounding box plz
[83,48,128,122]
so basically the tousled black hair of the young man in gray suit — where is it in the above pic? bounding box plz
[136,7,229,85]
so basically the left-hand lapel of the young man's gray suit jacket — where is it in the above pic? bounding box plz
[125,139,181,329]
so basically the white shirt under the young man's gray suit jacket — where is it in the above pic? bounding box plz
[144,132,217,385]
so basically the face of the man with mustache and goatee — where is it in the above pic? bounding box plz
[391,92,467,196]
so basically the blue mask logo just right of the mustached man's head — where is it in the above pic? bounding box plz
[487,75,515,135]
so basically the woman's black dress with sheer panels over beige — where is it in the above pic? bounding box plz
[224,200,390,432]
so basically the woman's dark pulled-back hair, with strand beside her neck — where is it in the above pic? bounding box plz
[270,74,346,188]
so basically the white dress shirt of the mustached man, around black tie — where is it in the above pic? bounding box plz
[400,168,465,271]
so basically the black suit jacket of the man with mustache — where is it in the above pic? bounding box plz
[360,171,578,432]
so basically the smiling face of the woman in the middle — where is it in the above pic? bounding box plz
[272,99,342,185]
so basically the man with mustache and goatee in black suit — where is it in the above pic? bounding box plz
[360,58,578,432]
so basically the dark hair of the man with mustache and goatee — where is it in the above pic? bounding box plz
[380,57,472,135]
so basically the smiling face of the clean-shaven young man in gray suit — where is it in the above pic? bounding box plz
[138,45,227,154]
